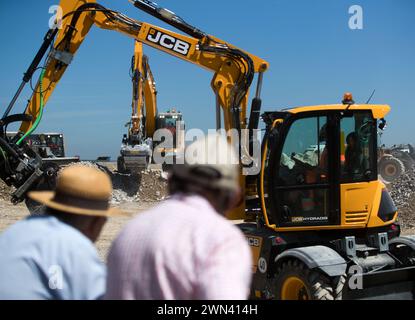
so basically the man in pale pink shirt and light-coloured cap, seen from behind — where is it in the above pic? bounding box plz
[105,135,252,300]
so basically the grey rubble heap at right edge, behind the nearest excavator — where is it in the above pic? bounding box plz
[388,168,415,229]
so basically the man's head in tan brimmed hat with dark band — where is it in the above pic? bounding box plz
[29,165,121,242]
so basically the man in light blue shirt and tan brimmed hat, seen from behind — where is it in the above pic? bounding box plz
[0,165,119,300]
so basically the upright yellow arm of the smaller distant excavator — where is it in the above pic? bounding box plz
[131,41,157,138]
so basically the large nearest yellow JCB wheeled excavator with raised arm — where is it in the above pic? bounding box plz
[0,0,415,300]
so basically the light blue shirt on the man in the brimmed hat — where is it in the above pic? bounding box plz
[0,215,106,300]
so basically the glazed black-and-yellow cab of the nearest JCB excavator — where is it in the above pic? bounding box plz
[263,106,384,228]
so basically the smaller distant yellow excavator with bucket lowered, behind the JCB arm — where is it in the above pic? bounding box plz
[117,41,184,174]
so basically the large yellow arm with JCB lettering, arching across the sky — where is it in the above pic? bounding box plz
[20,0,268,132]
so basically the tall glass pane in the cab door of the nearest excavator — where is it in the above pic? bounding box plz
[273,117,330,226]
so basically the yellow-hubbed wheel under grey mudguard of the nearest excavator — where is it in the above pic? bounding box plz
[273,259,346,300]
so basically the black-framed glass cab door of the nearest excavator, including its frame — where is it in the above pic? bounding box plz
[267,113,340,227]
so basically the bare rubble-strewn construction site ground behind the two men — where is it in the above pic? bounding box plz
[0,163,415,261]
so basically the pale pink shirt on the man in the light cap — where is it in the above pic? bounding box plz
[106,195,252,300]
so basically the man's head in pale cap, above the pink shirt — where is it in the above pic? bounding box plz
[169,134,241,214]
